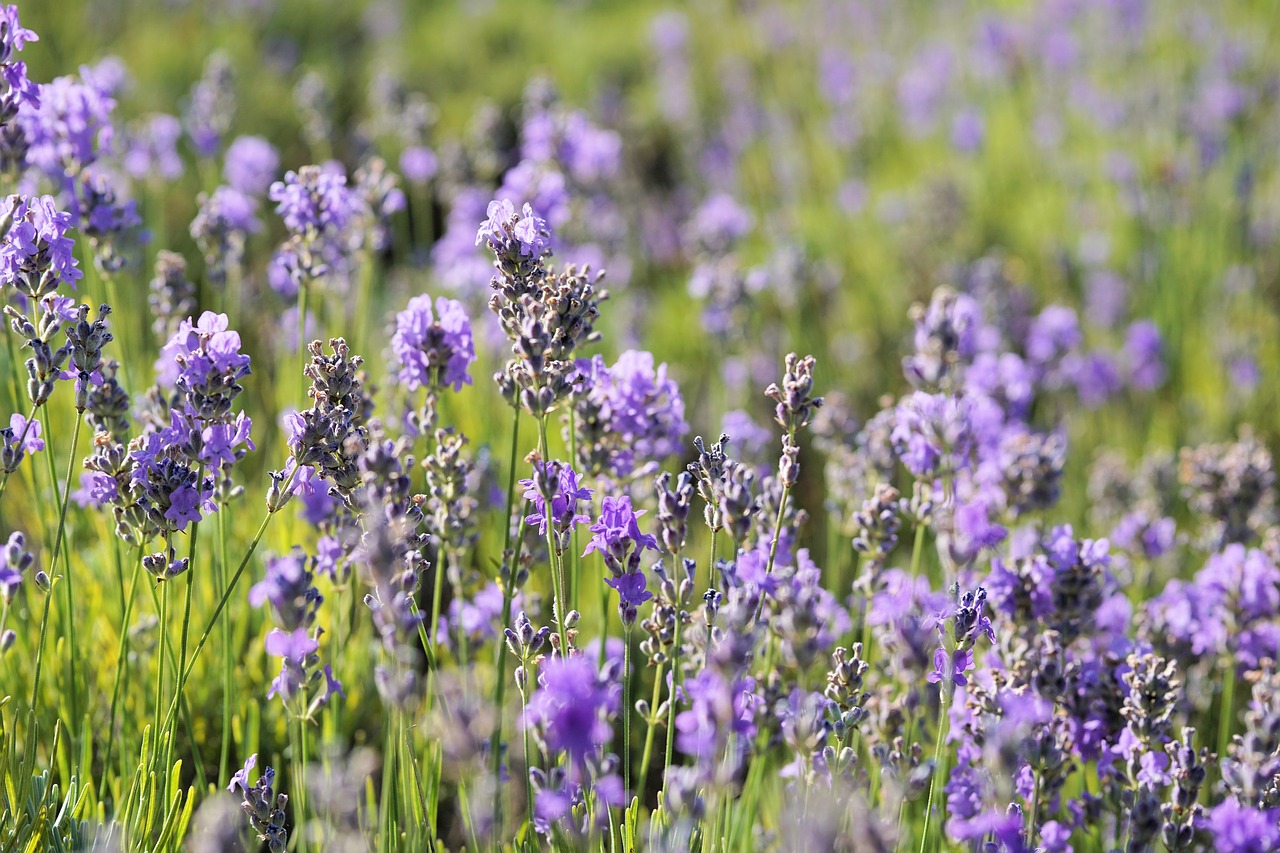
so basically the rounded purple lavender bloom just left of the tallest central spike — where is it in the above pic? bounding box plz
[392,293,476,391]
